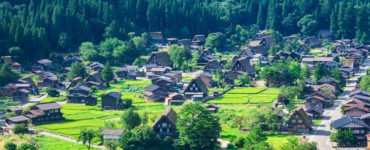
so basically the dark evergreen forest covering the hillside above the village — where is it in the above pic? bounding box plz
[0,0,370,62]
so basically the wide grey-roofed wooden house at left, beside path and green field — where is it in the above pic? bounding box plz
[24,102,64,124]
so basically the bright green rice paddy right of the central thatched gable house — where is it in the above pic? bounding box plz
[208,87,279,104]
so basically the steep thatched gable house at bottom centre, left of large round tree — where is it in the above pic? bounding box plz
[152,107,179,138]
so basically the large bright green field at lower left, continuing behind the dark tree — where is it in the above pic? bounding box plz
[37,103,173,138]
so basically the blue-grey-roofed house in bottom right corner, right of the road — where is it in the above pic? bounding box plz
[332,116,369,146]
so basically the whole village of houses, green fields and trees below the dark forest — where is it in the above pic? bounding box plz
[0,30,370,149]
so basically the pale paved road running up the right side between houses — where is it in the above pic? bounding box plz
[308,57,370,150]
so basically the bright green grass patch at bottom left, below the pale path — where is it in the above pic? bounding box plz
[37,136,98,150]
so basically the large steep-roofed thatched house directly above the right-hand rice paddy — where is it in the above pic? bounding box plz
[231,58,256,78]
